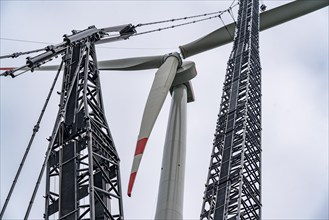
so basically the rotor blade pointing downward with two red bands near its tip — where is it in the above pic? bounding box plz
[128,53,180,197]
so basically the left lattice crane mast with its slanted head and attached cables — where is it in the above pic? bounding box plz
[1,7,238,219]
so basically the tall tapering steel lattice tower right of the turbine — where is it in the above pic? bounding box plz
[200,0,261,220]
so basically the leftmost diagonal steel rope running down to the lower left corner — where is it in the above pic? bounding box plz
[0,61,63,219]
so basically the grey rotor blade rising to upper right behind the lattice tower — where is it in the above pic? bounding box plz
[179,0,329,59]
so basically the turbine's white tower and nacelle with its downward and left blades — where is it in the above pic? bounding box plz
[83,53,197,219]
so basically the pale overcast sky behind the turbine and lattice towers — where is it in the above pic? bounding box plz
[0,0,329,220]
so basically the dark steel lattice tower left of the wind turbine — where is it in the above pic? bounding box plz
[45,35,123,220]
